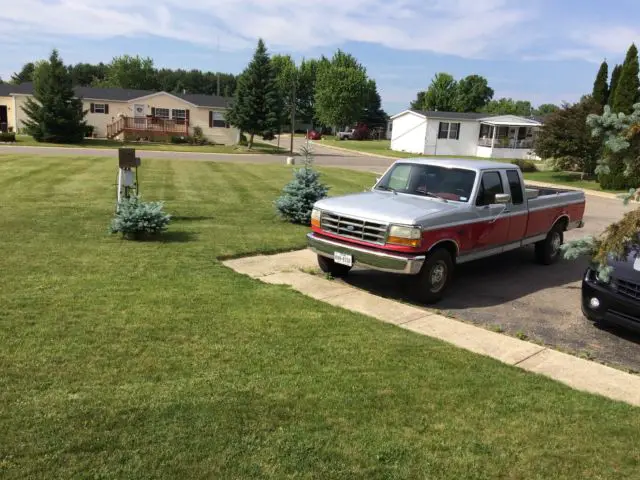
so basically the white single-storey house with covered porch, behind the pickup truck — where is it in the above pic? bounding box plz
[390,110,542,159]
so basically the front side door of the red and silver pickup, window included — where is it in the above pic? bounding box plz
[472,170,510,253]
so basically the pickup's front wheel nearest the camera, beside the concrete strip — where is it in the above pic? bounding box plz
[411,248,454,304]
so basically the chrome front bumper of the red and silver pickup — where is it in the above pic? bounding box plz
[307,233,425,275]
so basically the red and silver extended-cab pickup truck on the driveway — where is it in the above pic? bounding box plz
[307,158,585,303]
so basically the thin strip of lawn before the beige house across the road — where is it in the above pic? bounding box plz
[9,135,284,154]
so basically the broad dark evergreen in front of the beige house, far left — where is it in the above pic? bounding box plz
[23,50,87,143]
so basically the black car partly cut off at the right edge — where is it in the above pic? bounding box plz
[582,255,640,331]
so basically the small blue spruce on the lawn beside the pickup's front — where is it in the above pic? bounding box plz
[275,147,329,225]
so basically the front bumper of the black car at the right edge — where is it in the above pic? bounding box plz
[582,272,640,331]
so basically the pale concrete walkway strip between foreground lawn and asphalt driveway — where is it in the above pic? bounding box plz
[224,250,640,406]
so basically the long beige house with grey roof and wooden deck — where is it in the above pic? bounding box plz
[0,83,239,145]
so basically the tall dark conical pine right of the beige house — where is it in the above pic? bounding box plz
[227,39,282,148]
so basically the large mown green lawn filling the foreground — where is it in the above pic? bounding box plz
[0,155,640,479]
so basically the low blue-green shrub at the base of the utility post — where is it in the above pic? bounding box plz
[111,196,171,239]
